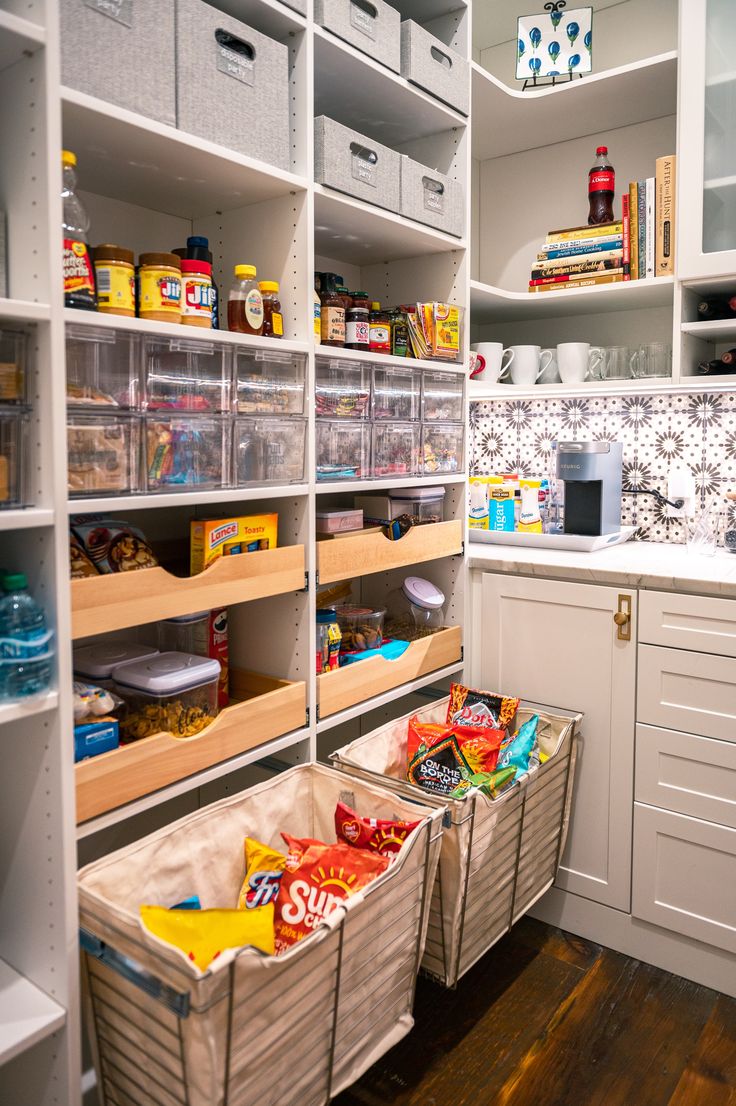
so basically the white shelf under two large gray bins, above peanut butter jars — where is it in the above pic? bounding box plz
[62,88,307,219]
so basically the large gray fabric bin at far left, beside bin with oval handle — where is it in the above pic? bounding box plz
[60,0,176,127]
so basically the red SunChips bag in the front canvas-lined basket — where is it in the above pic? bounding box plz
[274,833,391,953]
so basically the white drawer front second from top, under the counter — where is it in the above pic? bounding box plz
[636,645,736,741]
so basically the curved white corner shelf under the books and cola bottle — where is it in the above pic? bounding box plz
[470,277,674,325]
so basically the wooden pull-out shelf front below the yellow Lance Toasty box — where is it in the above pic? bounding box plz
[72,545,304,639]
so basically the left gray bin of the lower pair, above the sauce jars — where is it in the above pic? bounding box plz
[314,115,401,211]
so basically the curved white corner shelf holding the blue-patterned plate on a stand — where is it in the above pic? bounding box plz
[471,51,677,161]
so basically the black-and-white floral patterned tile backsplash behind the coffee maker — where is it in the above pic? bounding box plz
[470,390,736,542]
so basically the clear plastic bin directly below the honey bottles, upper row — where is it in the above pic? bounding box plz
[234,347,307,415]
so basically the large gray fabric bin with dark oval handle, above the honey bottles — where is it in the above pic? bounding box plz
[176,0,291,169]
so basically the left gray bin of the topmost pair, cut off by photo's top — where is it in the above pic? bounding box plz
[314,0,402,73]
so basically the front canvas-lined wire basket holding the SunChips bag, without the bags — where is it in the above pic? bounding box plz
[79,764,443,1106]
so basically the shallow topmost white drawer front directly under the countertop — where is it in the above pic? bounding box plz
[639,592,736,657]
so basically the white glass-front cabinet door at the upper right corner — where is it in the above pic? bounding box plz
[676,0,736,280]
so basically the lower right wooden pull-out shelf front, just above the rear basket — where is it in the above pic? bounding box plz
[317,626,463,718]
